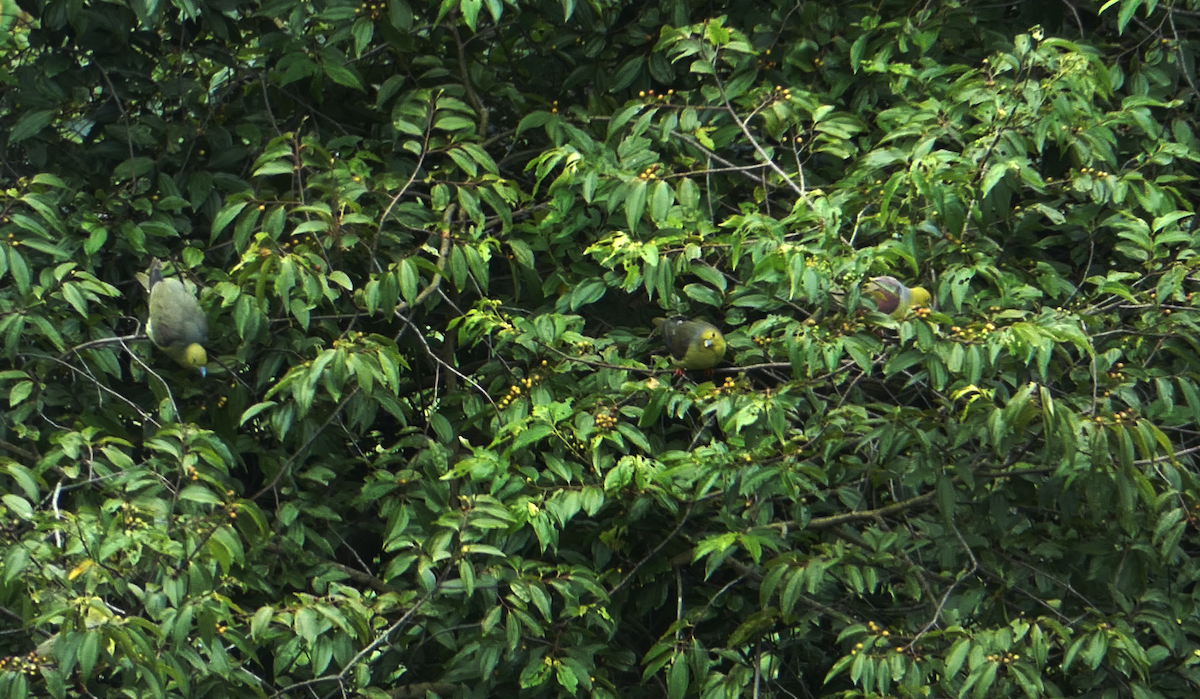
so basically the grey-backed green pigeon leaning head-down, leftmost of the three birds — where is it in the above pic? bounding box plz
[146,259,209,376]
